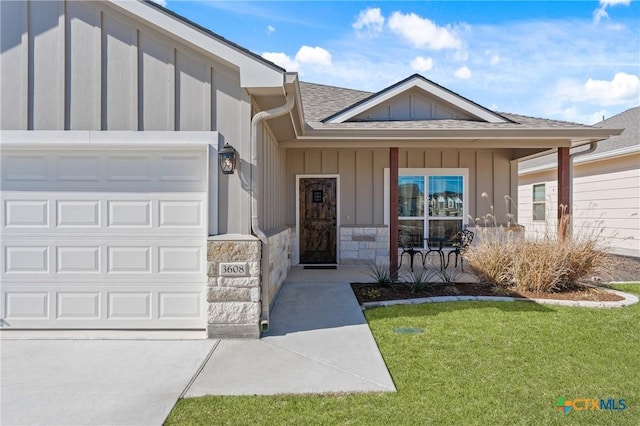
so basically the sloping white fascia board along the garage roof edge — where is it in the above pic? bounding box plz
[109,0,285,87]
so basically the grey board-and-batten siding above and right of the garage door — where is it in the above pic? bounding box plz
[0,0,251,234]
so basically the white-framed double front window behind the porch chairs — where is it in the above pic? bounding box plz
[398,169,468,248]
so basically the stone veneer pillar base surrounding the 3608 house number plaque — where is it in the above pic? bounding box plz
[207,234,262,339]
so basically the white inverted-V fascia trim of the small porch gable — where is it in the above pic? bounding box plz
[327,77,508,123]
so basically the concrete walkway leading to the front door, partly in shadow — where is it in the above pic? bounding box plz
[185,267,395,397]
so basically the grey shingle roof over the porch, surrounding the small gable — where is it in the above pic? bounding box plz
[300,82,591,129]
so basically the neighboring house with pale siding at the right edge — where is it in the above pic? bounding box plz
[518,107,640,257]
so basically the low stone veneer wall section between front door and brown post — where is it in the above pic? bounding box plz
[339,226,389,265]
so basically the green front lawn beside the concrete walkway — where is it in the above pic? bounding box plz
[167,285,640,425]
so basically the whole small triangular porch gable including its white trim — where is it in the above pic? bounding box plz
[324,74,510,123]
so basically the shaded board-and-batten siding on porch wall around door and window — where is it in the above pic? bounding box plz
[286,148,517,226]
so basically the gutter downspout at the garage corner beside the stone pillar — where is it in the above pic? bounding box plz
[251,93,295,331]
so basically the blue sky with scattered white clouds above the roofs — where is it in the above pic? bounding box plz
[157,0,640,124]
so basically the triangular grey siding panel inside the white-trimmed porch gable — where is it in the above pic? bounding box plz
[348,88,478,122]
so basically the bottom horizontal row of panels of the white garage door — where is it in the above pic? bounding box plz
[3,282,206,329]
